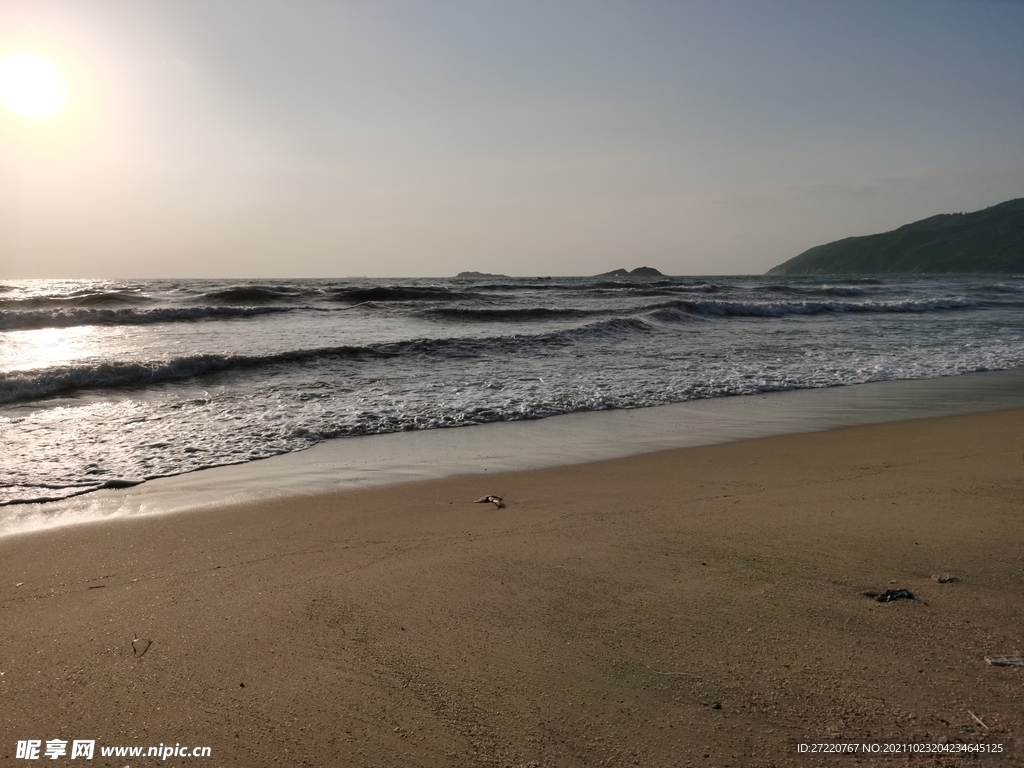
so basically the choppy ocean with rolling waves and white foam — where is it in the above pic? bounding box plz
[0,275,1024,514]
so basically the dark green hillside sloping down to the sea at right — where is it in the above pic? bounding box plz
[768,198,1024,274]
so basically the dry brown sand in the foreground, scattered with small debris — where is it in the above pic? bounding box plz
[0,411,1024,768]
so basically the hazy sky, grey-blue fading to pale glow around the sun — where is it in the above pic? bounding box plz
[0,0,1024,279]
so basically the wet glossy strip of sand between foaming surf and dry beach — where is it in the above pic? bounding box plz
[6,369,1024,538]
